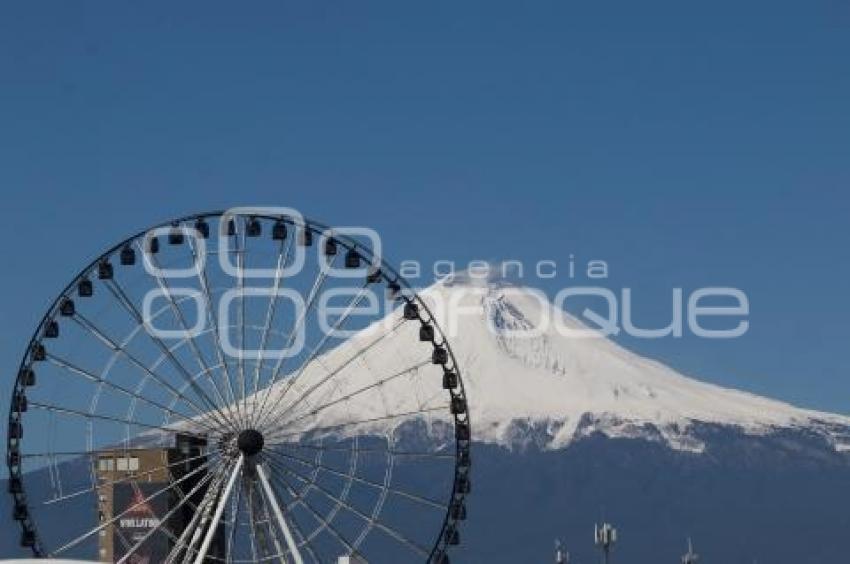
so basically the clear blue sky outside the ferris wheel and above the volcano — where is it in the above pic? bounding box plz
[0,0,850,413]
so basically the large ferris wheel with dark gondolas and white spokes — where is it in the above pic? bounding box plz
[7,208,470,564]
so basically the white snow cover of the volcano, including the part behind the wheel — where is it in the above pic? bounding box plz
[255,278,850,452]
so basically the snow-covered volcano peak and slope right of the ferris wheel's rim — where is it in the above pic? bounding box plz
[423,280,850,450]
